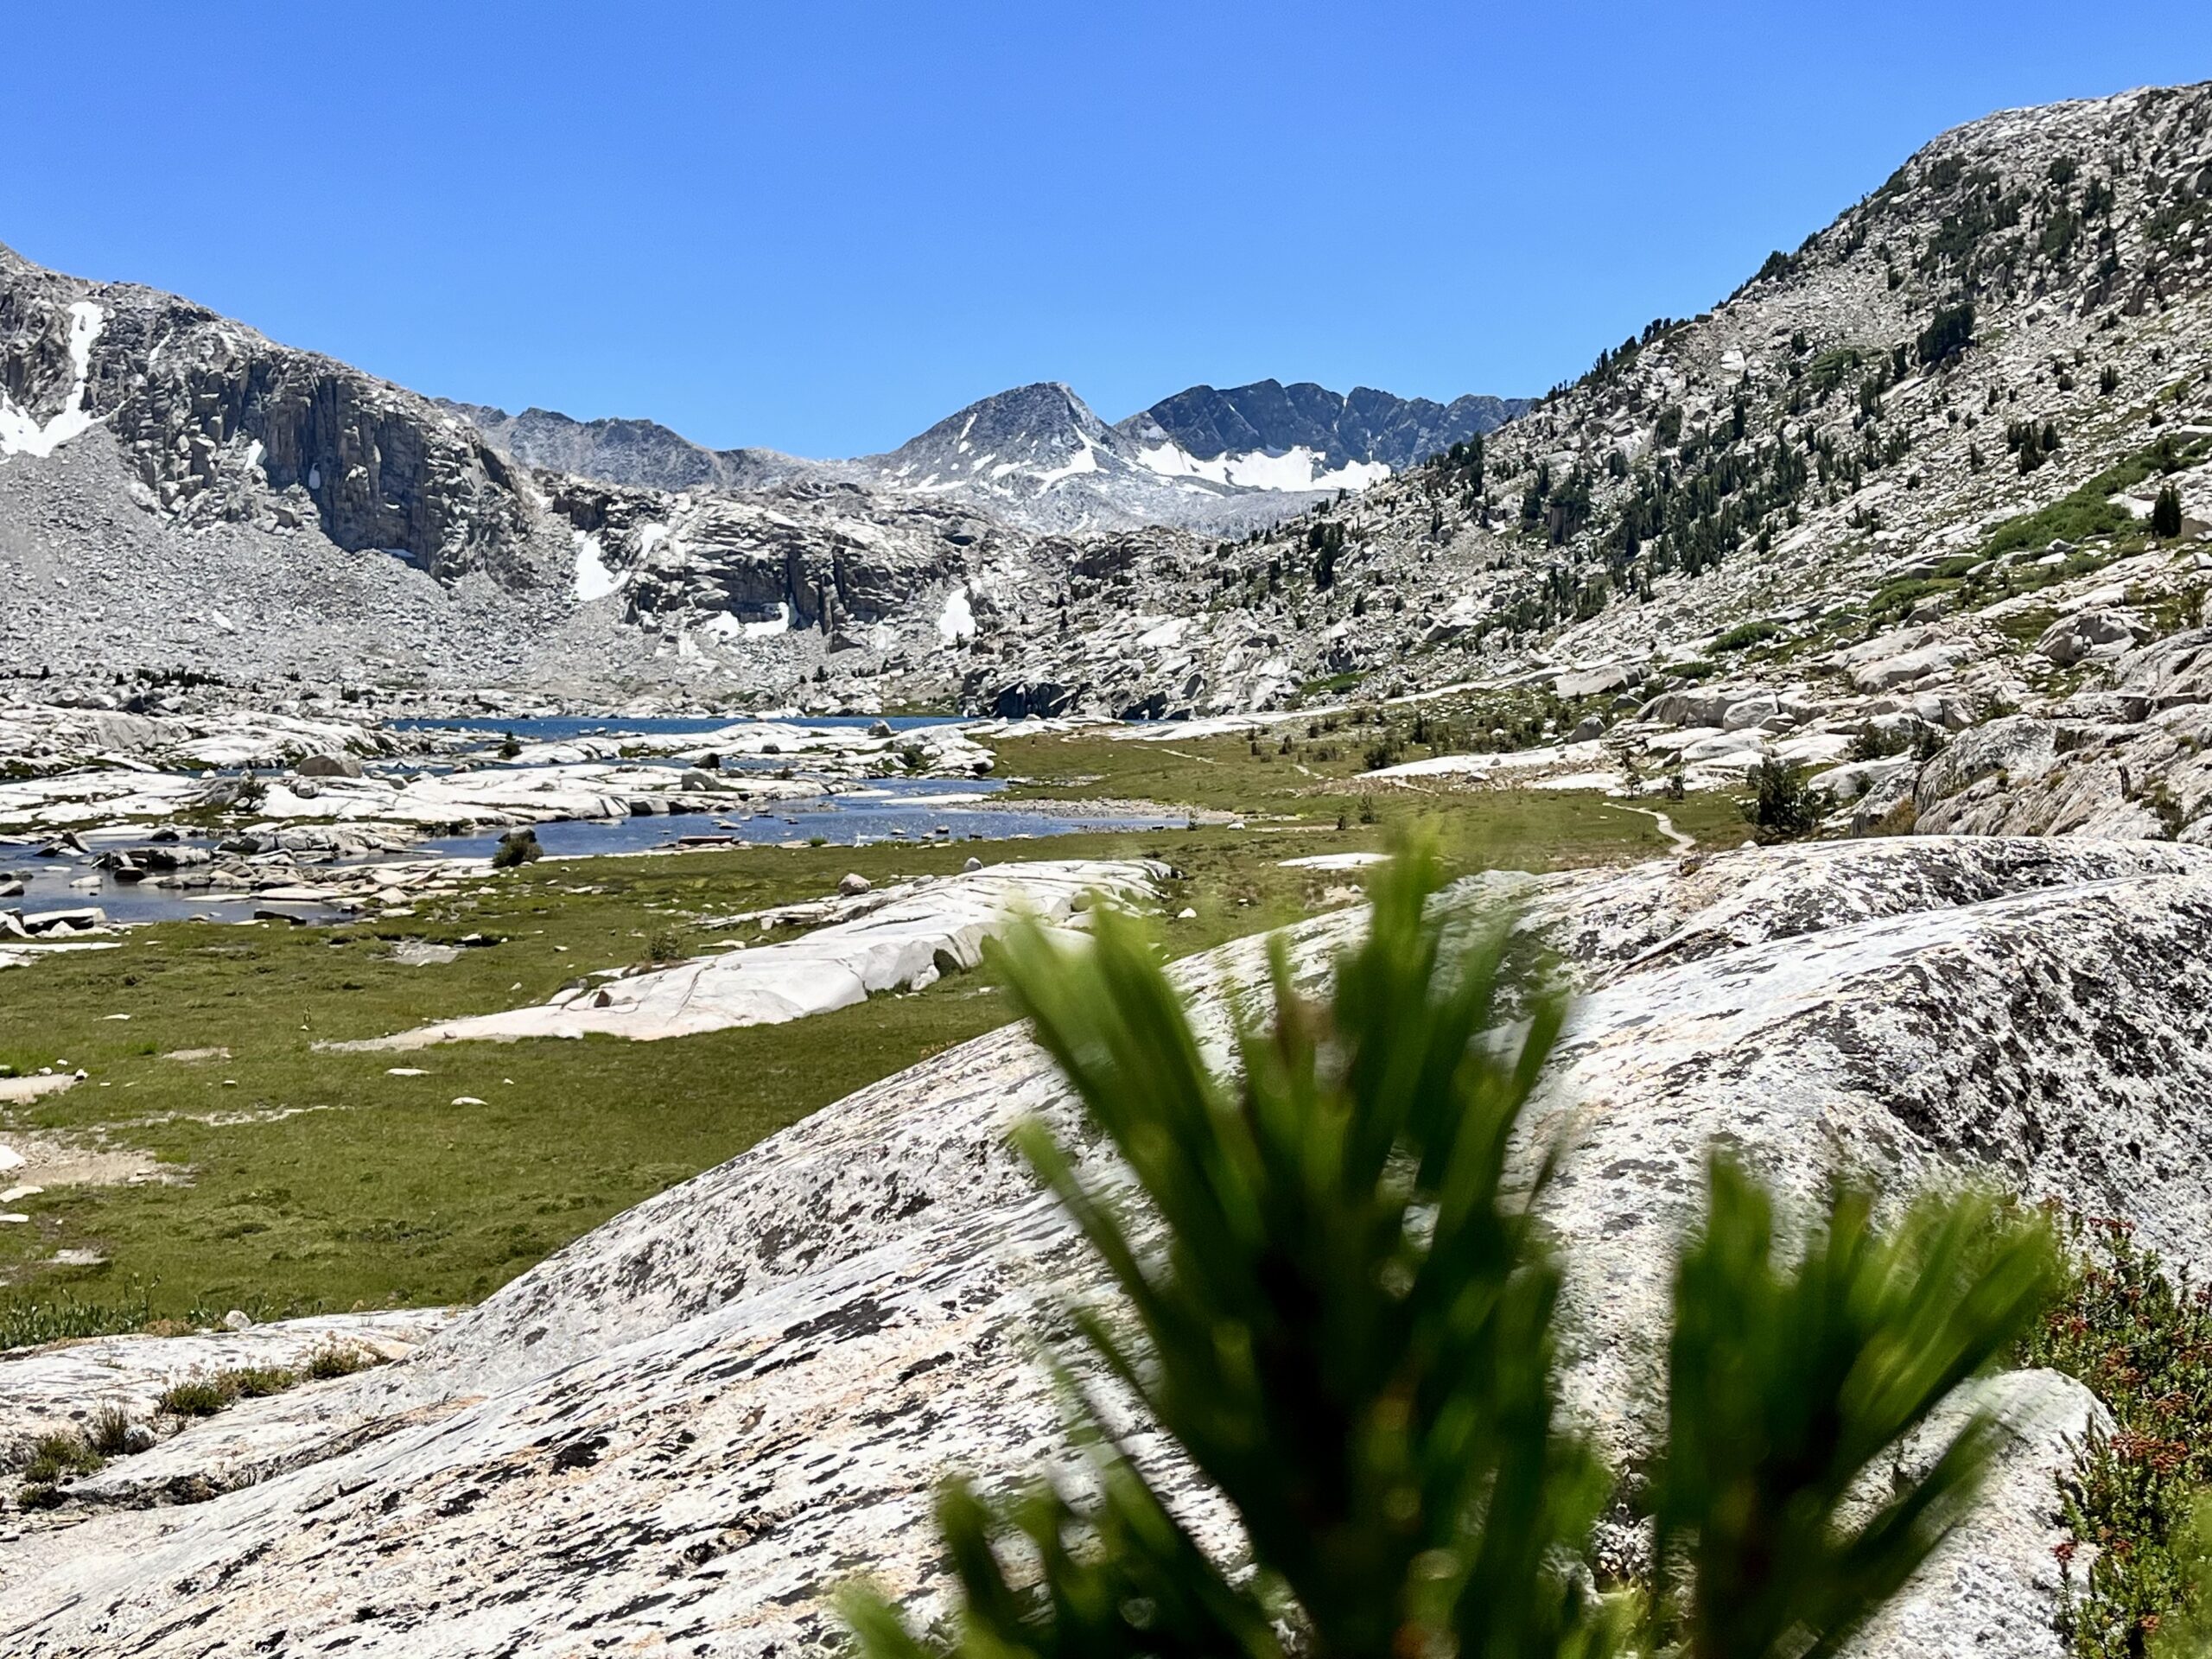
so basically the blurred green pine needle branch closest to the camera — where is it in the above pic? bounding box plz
[845,849,2053,1659]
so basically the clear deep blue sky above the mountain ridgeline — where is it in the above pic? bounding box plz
[13,0,2212,455]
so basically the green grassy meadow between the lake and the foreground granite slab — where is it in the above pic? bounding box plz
[0,769,1741,1344]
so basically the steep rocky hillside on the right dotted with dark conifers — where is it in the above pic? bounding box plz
[946,86,2212,712]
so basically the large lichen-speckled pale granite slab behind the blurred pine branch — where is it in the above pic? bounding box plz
[0,836,2212,1659]
